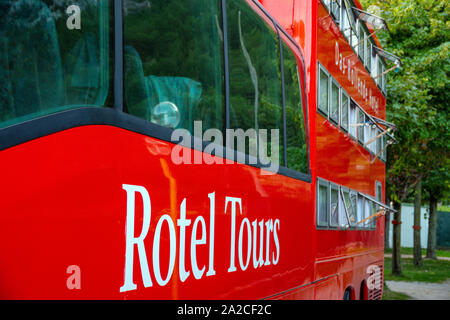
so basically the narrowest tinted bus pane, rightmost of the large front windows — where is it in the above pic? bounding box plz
[283,43,308,173]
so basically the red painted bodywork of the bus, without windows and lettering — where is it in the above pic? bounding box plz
[0,0,385,299]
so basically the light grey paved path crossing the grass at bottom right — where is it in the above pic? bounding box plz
[386,280,450,300]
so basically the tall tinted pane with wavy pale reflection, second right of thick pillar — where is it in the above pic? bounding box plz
[227,0,284,164]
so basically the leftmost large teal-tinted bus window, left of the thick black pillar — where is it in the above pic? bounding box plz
[0,0,110,128]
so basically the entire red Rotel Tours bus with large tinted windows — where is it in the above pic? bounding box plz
[0,0,387,299]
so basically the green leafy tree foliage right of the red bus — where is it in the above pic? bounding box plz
[362,0,450,201]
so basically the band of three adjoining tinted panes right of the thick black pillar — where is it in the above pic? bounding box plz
[124,0,308,178]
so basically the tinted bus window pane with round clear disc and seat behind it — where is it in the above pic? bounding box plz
[123,0,224,133]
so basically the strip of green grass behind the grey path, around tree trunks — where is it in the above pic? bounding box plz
[384,258,450,283]
